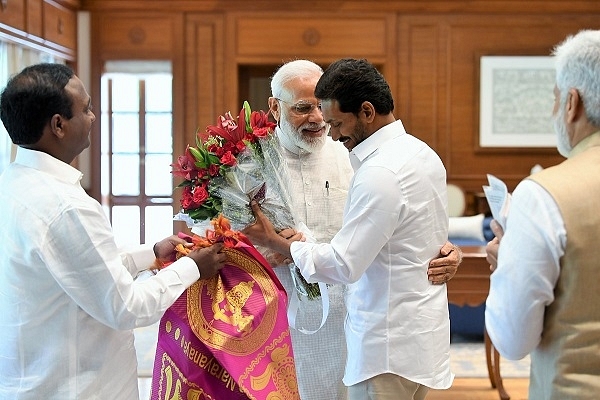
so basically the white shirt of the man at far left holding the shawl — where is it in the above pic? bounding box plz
[0,148,199,400]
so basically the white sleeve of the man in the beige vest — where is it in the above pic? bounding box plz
[485,180,567,360]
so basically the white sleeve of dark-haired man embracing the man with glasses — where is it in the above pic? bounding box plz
[290,167,405,284]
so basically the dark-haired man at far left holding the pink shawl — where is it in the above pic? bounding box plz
[0,64,226,400]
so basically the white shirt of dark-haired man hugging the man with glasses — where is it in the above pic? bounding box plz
[291,121,453,389]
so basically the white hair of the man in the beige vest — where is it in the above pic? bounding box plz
[553,30,600,127]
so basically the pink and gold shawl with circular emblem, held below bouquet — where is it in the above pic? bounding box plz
[151,217,300,400]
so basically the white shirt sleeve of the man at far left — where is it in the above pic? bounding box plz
[41,202,199,330]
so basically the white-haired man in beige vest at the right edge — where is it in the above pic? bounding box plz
[485,31,600,400]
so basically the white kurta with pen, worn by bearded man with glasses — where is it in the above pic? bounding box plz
[275,128,354,400]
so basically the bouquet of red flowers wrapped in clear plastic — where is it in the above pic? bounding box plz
[171,102,320,298]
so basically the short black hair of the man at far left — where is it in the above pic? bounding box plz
[0,63,75,145]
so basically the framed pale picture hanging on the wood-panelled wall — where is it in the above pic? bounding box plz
[479,56,556,147]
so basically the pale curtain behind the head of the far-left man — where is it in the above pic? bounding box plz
[0,41,64,173]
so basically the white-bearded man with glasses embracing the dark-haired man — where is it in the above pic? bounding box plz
[269,60,460,400]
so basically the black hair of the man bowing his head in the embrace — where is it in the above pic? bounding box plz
[315,58,394,115]
